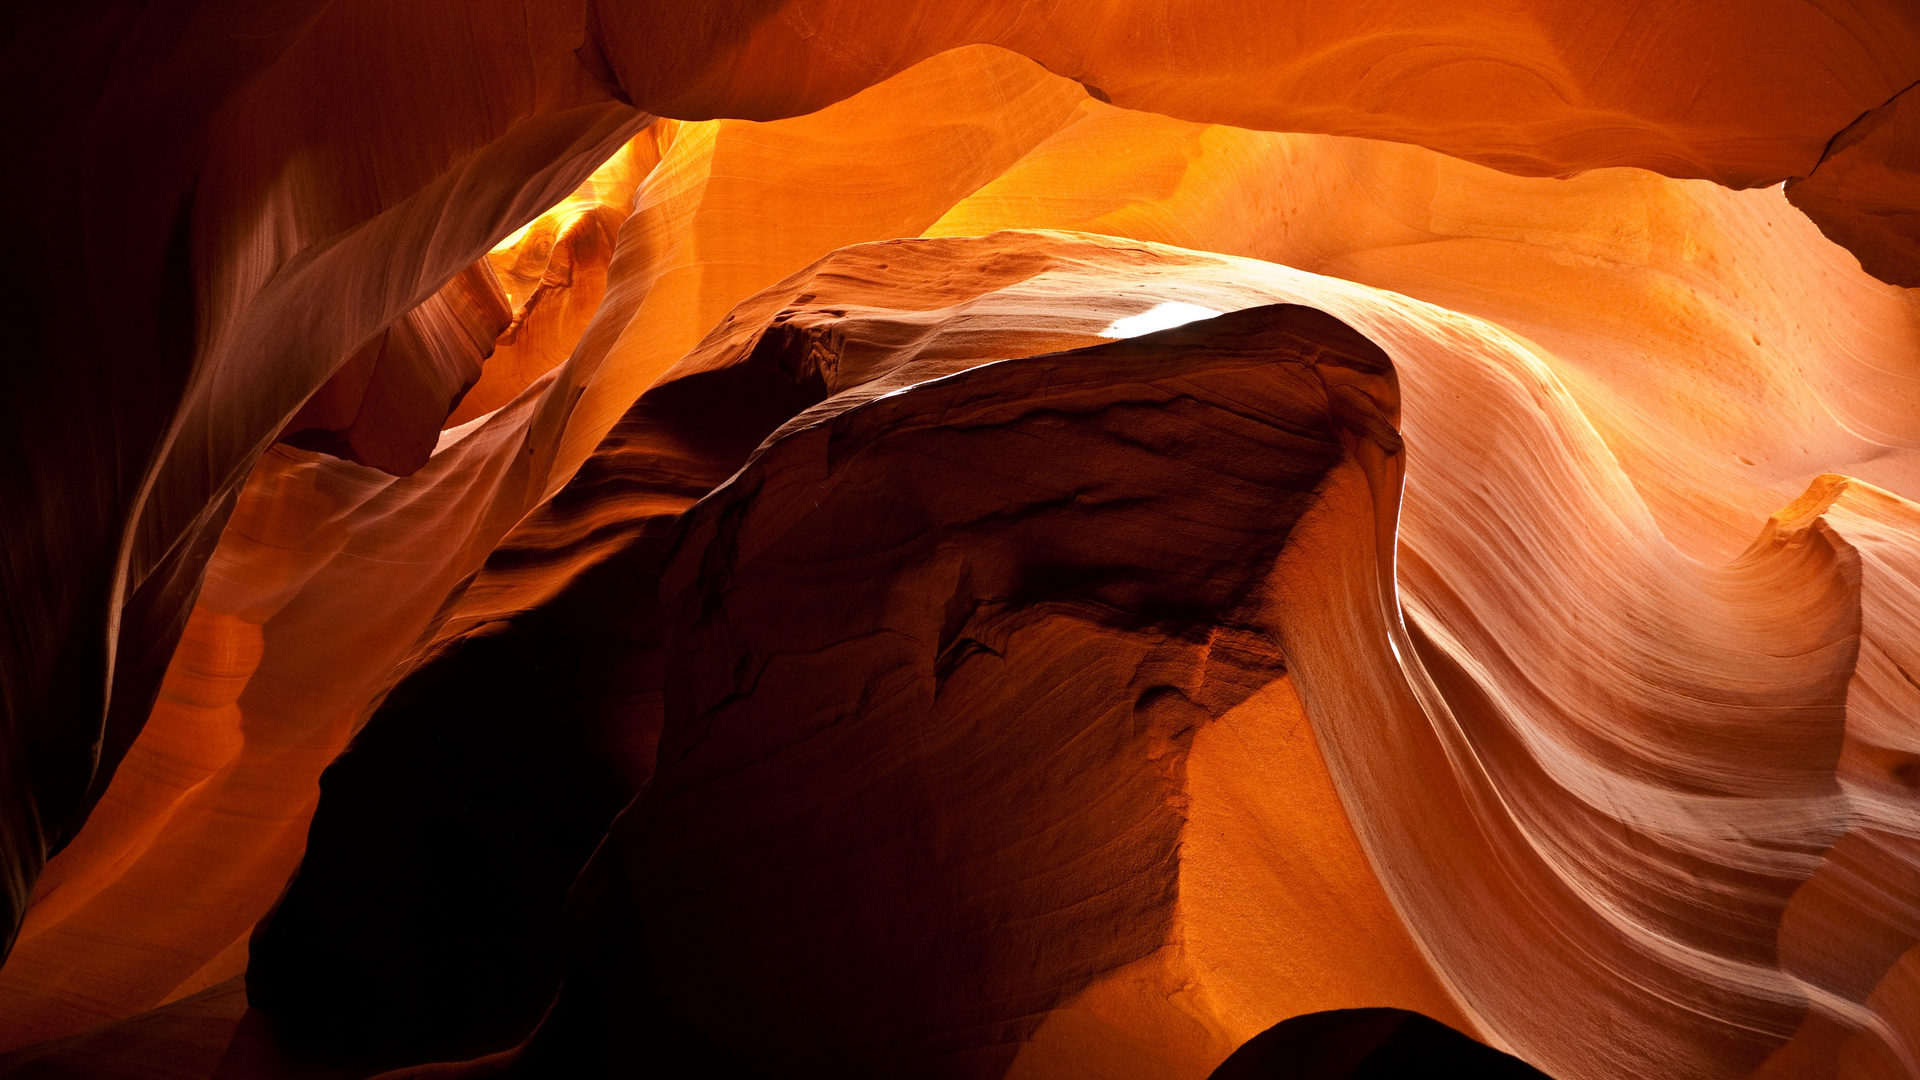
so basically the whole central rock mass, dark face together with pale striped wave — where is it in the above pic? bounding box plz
[41,234,1910,1076]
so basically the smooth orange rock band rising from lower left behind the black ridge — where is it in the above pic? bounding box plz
[0,50,1113,1045]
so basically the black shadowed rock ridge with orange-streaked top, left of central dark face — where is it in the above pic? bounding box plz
[250,315,840,1061]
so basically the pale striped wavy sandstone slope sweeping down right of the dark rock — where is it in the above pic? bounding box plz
[476,235,1912,1076]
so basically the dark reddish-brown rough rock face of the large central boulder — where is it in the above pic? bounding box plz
[612,307,1386,1074]
